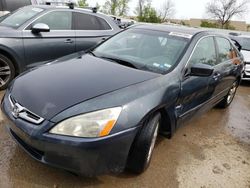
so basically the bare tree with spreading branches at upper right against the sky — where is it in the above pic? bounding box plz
[206,0,248,29]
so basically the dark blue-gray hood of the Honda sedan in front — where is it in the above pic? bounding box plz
[10,54,159,120]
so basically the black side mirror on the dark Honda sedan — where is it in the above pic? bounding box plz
[189,63,214,77]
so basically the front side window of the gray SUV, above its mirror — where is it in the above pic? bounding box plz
[29,11,72,30]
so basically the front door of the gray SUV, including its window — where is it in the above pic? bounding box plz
[23,10,75,67]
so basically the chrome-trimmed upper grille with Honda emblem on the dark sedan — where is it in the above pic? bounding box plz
[9,95,44,124]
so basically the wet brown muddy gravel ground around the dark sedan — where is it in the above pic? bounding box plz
[0,82,250,188]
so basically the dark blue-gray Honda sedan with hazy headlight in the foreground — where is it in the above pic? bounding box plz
[2,25,243,176]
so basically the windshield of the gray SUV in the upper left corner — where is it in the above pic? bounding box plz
[0,7,44,28]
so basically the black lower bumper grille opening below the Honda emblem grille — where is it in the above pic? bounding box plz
[10,129,44,160]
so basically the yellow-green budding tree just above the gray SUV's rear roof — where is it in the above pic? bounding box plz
[102,0,130,16]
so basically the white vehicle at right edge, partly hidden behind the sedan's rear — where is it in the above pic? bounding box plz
[230,34,250,80]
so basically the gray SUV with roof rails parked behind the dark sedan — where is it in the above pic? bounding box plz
[0,5,120,89]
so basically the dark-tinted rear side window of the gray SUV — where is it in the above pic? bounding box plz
[74,12,111,30]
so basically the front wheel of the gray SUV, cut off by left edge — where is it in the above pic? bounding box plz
[0,54,15,90]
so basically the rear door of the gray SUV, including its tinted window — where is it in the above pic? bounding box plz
[73,12,115,51]
